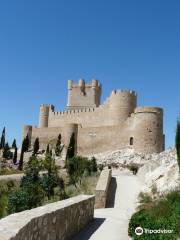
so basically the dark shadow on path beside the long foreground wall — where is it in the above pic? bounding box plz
[72,218,106,240]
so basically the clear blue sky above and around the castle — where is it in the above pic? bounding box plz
[0,0,180,147]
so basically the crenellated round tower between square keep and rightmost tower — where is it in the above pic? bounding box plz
[109,90,137,125]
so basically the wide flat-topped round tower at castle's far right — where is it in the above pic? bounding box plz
[133,107,164,153]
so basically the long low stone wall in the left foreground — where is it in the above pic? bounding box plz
[0,195,94,240]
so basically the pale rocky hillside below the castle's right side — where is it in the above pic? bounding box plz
[92,149,180,194]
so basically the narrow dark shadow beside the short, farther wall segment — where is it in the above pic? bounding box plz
[106,177,117,208]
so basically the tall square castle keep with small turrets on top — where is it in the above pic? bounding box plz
[67,79,101,110]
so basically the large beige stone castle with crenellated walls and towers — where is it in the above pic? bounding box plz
[23,79,165,155]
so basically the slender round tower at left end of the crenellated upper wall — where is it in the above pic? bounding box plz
[39,104,54,128]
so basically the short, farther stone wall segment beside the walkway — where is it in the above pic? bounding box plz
[95,169,112,208]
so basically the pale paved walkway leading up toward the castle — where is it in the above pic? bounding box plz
[74,170,142,240]
